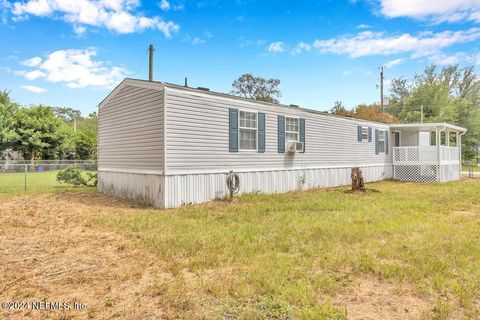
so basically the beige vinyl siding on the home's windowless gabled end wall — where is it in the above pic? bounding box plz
[98,85,164,170]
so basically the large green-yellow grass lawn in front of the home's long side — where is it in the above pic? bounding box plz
[98,180,480,319]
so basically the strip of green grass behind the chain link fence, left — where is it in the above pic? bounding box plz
[0,170,95,194]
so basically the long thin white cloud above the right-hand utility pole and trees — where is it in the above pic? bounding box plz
[313,28,480,58]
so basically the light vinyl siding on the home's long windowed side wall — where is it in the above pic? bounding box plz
[165,86,391,174]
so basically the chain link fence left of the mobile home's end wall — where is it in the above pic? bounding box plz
[0,160,97,194]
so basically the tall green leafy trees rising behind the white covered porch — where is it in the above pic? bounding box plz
[388,64,480,158]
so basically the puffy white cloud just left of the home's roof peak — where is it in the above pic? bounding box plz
[20,49,127,88]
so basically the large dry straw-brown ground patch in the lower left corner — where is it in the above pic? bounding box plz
[0,193,174,319]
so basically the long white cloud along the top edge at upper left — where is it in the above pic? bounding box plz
[11,0,179,37]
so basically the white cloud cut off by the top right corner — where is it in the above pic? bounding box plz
[380,0,480,23]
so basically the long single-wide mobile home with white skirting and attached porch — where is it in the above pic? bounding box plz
[98,79,466,208]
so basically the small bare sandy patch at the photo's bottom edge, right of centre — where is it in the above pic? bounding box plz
[333,278,432,320]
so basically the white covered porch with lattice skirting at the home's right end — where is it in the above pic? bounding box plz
[391,123,466,182]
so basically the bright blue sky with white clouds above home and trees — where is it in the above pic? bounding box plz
[0,0,480,114]
